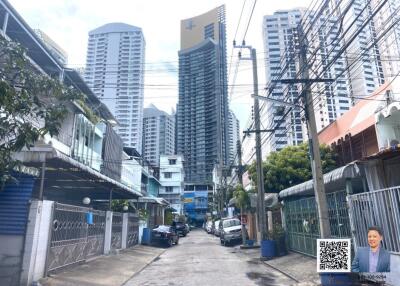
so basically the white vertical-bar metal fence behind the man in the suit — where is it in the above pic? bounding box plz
[348,186,400,254]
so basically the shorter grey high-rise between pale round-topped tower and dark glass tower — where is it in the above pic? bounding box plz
[142,104,175,166]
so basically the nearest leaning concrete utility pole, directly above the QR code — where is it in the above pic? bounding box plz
[298,25,331,238]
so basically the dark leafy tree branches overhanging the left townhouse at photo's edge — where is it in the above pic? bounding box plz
[0,36,83,189]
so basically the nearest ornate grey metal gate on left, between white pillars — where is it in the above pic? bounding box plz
[46,203,106,272]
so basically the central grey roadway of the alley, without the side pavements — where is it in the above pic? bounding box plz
[125,229,295,286]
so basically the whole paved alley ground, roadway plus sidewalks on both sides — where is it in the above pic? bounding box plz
[40,229,319,286]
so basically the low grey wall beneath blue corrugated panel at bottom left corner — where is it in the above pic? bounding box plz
[0,235,24,286]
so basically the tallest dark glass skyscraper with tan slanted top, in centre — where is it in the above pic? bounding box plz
[177,6,229,190]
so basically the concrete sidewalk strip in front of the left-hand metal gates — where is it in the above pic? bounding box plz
[39,245,165,286]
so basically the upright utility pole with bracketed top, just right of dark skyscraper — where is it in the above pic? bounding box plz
[233,42,266,244]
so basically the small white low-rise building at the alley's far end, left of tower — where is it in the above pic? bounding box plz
[158,155,185,214]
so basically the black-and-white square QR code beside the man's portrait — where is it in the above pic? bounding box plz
[317,239,351,272]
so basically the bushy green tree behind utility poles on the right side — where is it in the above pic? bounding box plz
[249,144,337,193]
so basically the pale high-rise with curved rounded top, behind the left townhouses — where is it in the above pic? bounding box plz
[85,23,145,152]
